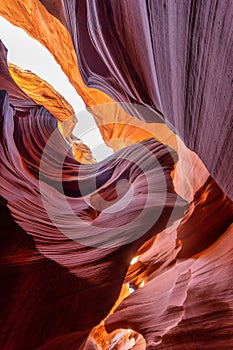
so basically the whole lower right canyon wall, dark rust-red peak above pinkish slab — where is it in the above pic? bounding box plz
[106,178,233,349]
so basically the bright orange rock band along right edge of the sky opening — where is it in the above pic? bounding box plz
[0,0,182,159]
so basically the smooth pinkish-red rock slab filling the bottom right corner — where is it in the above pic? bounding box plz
[106,225,233,349]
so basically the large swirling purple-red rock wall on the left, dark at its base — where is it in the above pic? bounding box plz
[0,42,187,349]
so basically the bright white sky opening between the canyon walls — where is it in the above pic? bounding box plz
[0,16,113,161]
